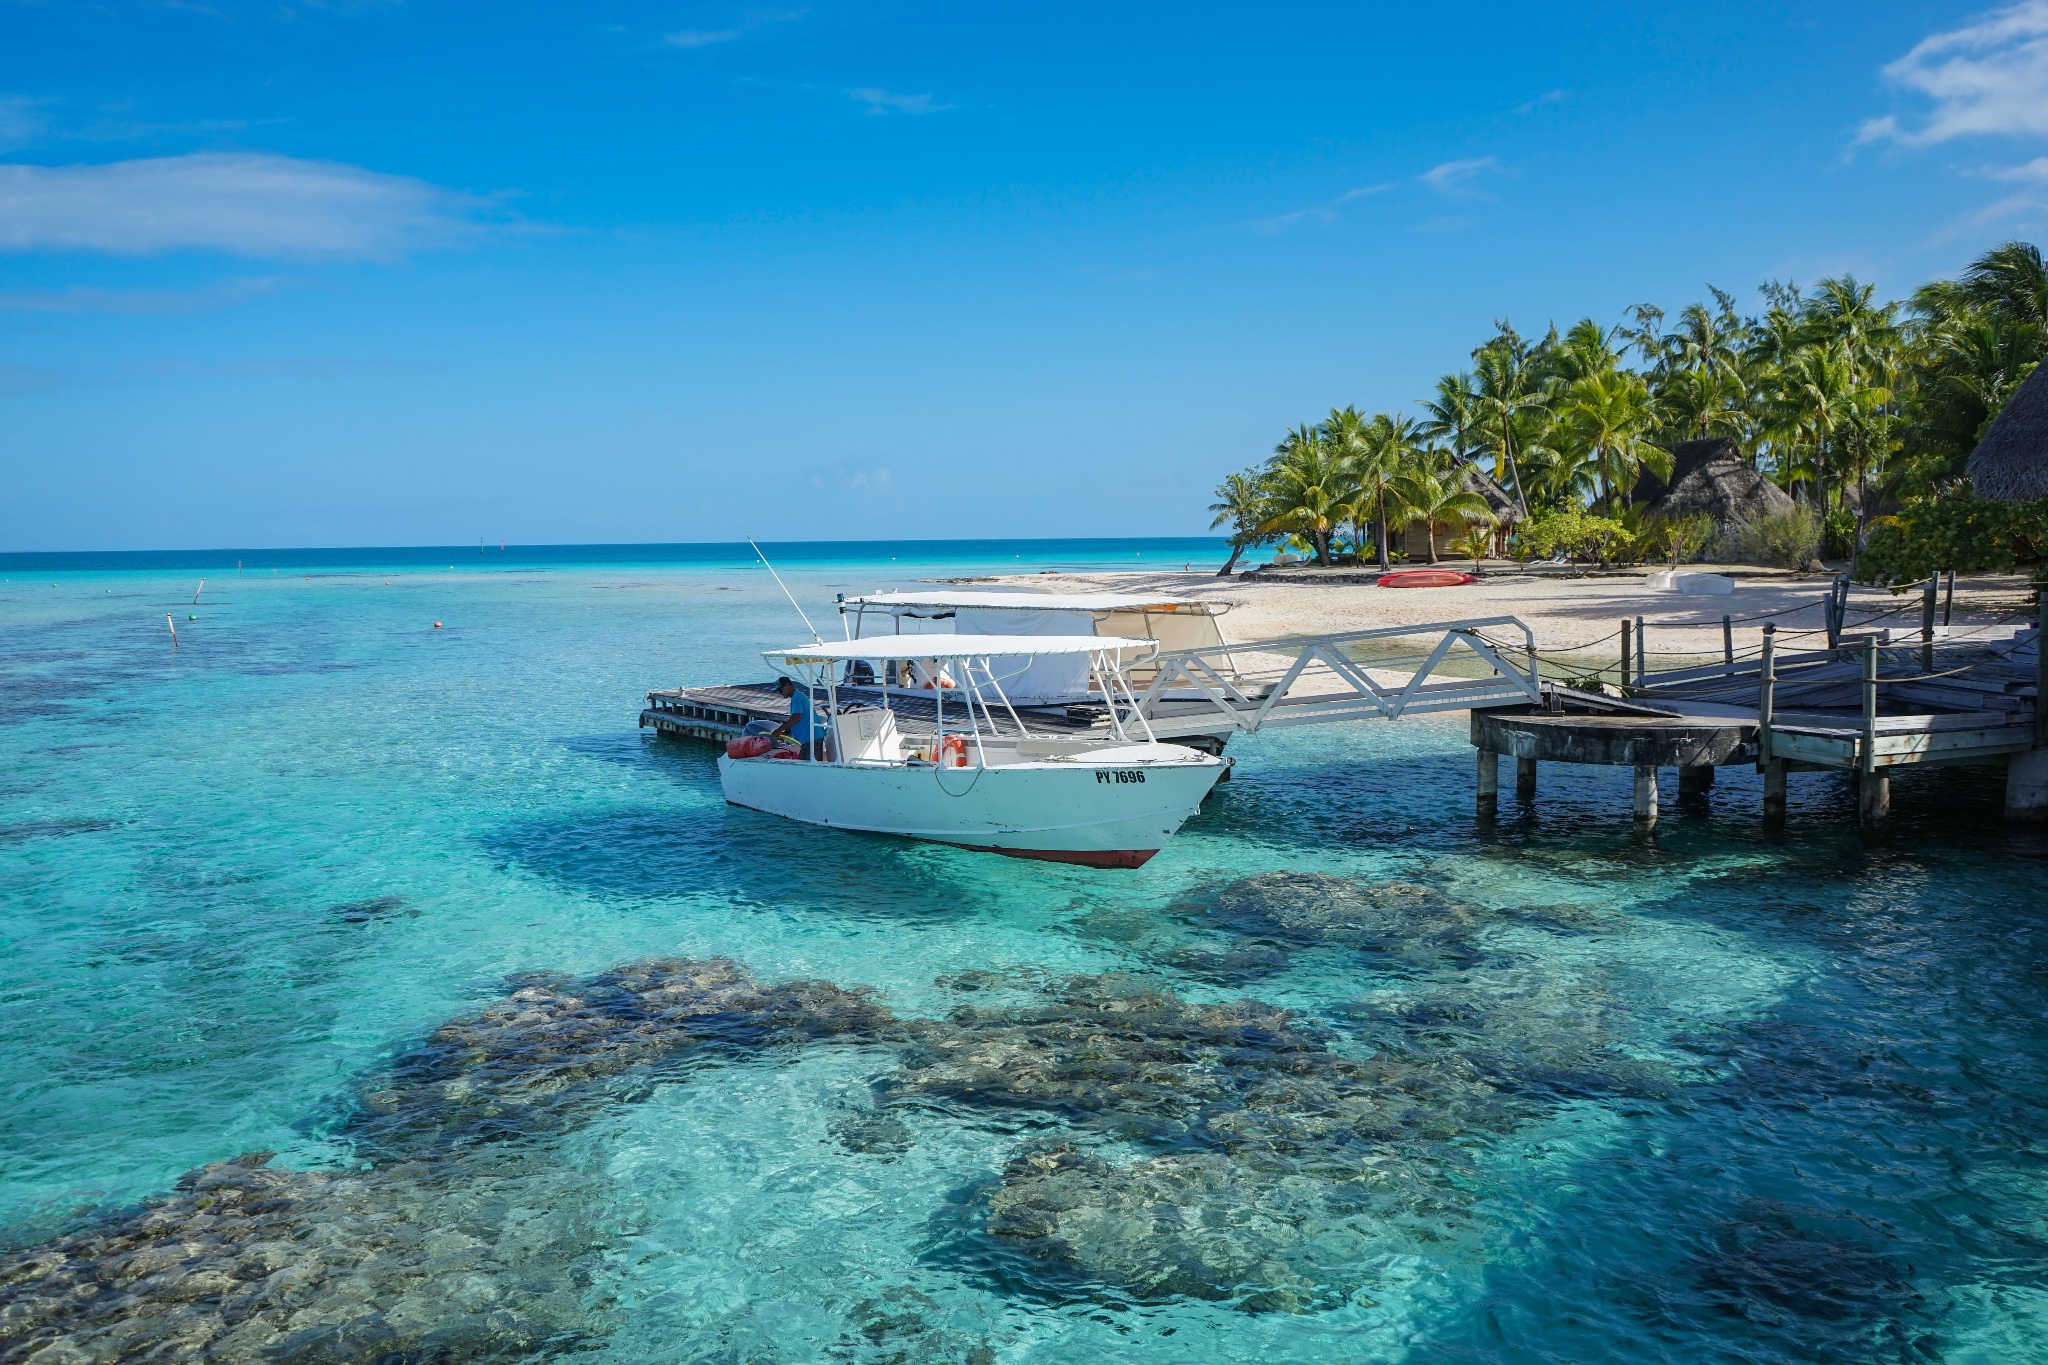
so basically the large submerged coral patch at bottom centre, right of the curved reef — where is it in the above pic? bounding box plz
[885,976,1649,1310]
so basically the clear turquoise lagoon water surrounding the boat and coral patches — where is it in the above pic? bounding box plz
[0,542,2048,1361]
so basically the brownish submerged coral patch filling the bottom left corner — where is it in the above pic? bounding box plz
[0,1152,594,1365]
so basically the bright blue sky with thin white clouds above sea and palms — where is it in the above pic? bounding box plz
[0,0,2048,551]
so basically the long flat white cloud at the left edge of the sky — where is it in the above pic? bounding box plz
[0,153,487,258]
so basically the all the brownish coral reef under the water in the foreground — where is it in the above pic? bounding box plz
[0,874,1671,1365]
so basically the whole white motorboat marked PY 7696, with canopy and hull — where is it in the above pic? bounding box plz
[719,634,1227,868]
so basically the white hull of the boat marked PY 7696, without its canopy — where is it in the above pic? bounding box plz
[719,745,1225,868]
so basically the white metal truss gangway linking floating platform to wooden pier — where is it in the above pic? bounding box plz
[1135,616,1542,739]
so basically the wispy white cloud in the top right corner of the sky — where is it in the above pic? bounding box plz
[1855,0,2048,147]
